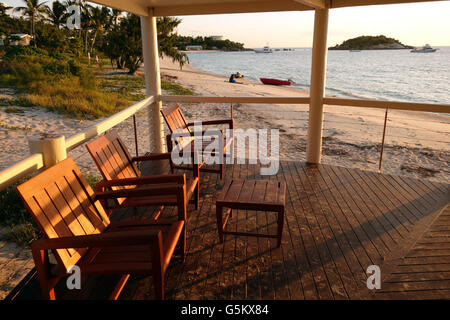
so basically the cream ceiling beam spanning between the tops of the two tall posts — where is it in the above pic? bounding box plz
[154,0,312,16]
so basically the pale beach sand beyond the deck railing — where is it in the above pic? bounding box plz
[0,58,450,299]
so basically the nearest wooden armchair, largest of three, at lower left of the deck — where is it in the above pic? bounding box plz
[17,158,186,300]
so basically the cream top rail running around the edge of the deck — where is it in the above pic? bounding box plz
[0,95,450,190]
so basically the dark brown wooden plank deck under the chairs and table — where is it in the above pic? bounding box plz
[10,162,450,299]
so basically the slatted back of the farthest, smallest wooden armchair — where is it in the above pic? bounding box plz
[161,104,194,147]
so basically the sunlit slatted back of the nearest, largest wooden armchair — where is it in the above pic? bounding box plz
[17,158,110,269]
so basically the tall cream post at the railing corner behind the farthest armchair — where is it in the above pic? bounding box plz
[141,8,164,152]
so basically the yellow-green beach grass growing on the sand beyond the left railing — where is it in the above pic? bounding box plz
[9,72,194,119]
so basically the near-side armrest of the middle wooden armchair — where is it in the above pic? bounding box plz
[95,174,186,191]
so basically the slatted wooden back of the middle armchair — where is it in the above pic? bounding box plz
[86,130,141,204]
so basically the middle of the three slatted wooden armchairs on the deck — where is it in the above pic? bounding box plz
[86,130,200,220]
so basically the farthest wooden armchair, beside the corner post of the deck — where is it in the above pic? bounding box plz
[161,104,234,179]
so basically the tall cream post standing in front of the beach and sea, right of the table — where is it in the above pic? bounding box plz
[306,9,328,163]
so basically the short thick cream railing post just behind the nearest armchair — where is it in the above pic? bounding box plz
[28,134,67,168]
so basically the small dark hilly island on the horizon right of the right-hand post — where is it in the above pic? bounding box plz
[328,35,413,50]
